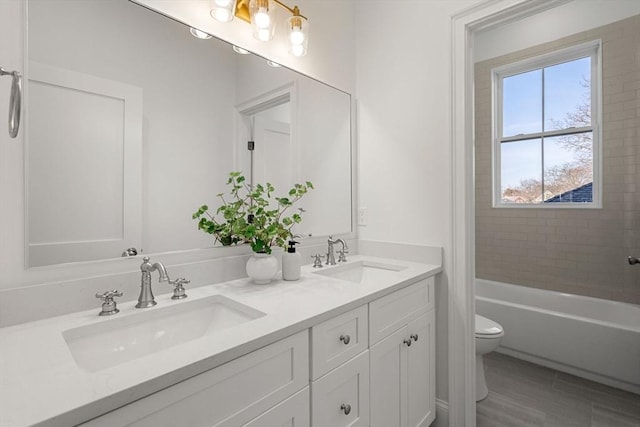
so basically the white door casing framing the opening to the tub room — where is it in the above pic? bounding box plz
[445,0,567,427]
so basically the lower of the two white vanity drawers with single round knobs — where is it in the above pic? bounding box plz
[311,350,369,427]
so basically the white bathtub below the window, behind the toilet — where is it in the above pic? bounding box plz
[475,279,640,394]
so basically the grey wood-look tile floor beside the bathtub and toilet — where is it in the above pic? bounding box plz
[476,352,640,427]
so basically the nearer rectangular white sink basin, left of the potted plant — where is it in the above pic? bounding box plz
[62,295,265,372]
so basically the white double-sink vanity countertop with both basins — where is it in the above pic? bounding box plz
[0,256,440,426]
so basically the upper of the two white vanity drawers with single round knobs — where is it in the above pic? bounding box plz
[311,304,369,380]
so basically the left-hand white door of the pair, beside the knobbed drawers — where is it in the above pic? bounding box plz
[369,327,407,427]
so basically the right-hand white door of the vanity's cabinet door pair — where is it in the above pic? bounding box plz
[407,310,435,427]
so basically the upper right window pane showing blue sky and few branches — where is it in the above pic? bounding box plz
[544,57,591,131]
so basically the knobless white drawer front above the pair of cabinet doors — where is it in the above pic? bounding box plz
[369,277,434,345]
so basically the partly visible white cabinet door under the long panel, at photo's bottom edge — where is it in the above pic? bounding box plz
[242,387,309,427]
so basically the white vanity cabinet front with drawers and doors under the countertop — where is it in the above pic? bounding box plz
[75,278,435,427]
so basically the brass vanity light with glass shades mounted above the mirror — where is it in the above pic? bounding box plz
[210,0,309,57]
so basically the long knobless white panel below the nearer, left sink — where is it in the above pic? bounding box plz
[82,330,309,427]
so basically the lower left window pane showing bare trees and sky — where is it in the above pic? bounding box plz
[500,139,542,203]
